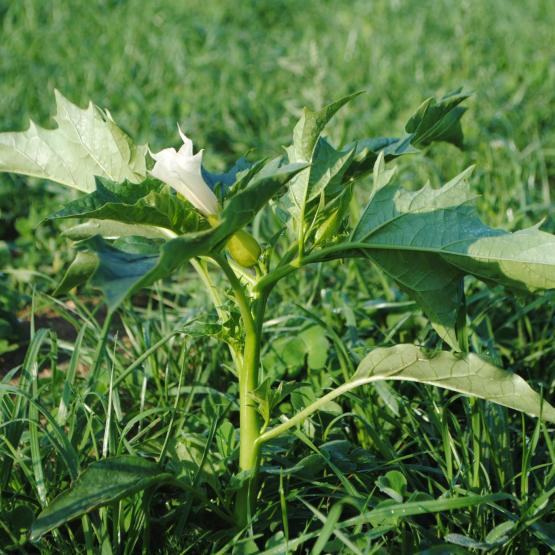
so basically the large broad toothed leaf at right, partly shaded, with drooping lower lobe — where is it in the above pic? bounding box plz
[346,168,555,347]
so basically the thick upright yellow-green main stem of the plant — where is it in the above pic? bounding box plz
[216,256,265,527]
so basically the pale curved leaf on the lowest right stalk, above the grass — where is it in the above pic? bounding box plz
[350,345,555,422]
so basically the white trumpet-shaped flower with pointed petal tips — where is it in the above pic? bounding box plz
[150,129,220,217]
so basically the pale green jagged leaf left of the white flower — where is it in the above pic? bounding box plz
[0,91,147,192]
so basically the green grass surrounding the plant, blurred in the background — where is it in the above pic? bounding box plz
[0,0,555,554]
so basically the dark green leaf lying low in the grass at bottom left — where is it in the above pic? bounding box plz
[31,455,172,541]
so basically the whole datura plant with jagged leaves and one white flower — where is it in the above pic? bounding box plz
[0,91,555,539]
